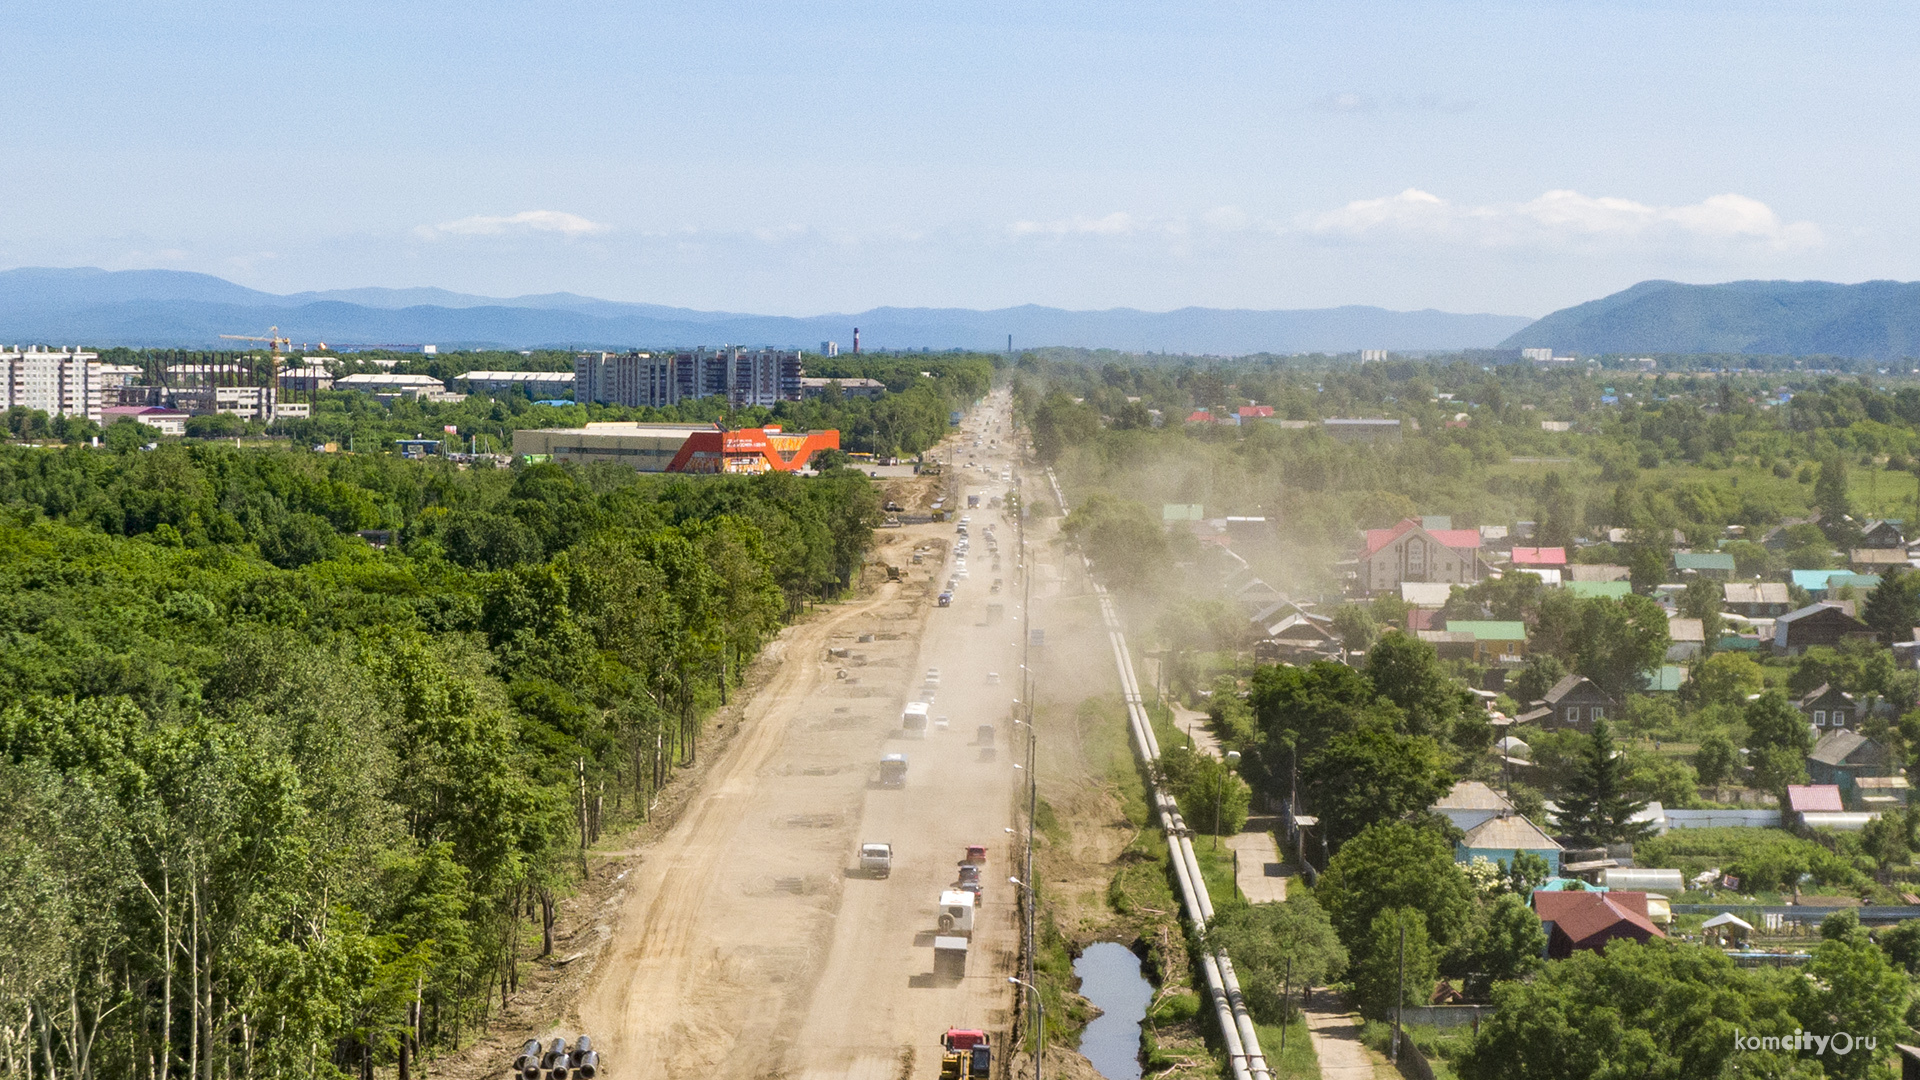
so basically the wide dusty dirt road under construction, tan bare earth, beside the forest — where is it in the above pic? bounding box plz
[578,397,1025,1080]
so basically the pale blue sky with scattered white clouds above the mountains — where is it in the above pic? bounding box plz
[0,0,1920,315]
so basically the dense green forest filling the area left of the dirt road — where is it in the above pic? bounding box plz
[0,440,879,1080]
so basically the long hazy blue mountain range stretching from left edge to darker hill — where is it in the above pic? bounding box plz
[0,267,1528,356]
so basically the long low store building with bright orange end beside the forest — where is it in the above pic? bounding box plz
[513,423,839,473]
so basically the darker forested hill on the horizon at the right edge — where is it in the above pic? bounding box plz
[1501,281,1920,359]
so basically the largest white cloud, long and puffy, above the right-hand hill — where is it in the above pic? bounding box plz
[1300,188,1822,250]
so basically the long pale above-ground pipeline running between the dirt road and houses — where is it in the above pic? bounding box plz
[1046,469,1273,1080]
